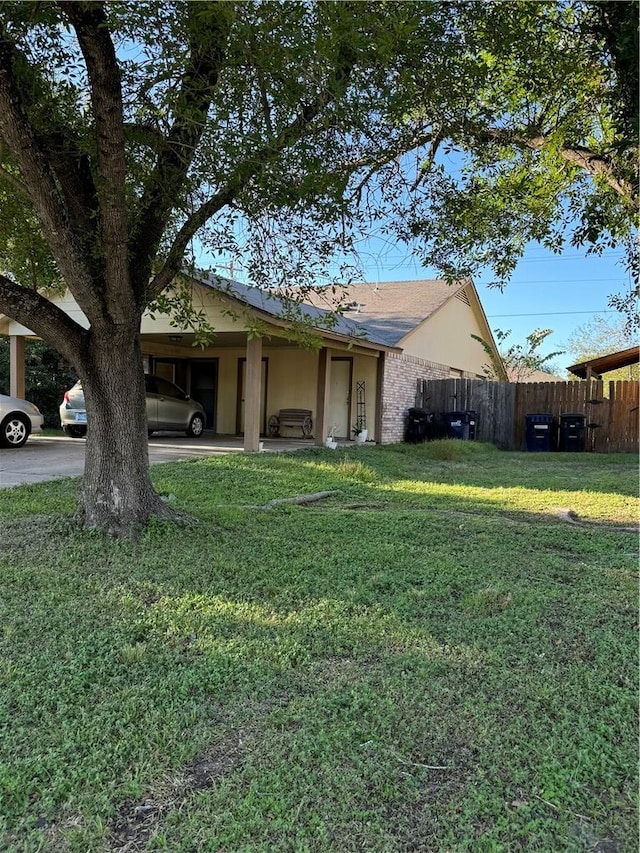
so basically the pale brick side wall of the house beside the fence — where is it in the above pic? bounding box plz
[379,352,450,444]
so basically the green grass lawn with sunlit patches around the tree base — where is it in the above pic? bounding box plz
[0,441,638,853]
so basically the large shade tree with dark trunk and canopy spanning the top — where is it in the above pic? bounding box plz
[0,0,637,533]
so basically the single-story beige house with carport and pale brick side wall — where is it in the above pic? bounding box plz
[0,273,508,451]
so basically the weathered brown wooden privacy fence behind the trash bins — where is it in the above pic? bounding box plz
[416,379,640,453]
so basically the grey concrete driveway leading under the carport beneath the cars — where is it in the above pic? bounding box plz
[0,433,313,488]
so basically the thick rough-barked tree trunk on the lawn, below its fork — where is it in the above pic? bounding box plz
[78,327,176,537]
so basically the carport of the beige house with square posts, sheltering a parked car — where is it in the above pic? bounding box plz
[0,274,400,452]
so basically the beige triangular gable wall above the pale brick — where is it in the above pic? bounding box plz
[401,298,488,378]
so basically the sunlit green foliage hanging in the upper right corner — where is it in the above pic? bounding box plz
[390,0,639,325]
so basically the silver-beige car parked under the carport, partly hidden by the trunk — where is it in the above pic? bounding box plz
[60,374,206,438]
